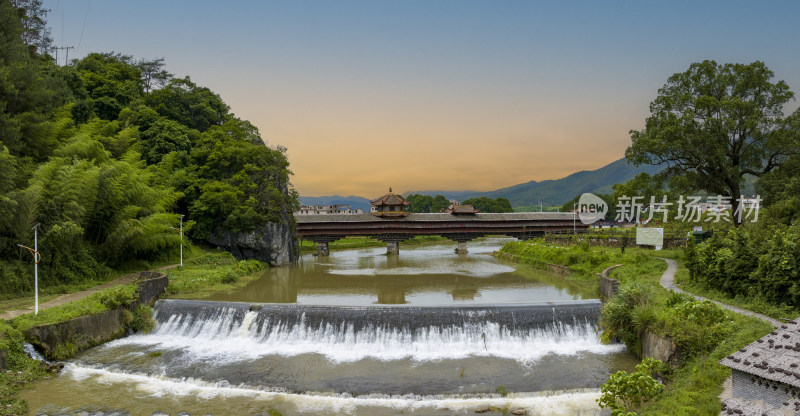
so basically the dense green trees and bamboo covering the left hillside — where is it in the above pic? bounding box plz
[0,0,297,294]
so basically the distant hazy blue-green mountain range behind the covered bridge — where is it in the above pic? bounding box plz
[300,158,662,211]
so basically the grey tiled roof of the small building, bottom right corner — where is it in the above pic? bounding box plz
[719,320,800,387]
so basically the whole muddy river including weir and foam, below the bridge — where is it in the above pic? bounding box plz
[23,239,635,416]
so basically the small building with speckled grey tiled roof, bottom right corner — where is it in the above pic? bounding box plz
[719,320,800,416]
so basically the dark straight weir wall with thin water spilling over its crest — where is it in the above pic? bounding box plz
[155,299,602,334]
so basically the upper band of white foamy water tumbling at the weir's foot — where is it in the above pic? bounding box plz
[105,312,625,363]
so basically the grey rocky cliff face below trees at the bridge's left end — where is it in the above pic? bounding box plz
[208,221,300,266]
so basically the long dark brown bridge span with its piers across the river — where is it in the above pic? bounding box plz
[295,212,588,255]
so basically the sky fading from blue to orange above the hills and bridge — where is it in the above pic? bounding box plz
[44,0,800,198]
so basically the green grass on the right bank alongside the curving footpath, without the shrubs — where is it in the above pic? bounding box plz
[501,241,776,415]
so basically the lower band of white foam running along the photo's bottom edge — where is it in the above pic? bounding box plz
[62,363,600,416]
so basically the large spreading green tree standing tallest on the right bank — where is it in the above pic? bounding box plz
[625,60,800,225]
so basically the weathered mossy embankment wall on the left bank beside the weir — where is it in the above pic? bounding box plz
[25,272,169,359]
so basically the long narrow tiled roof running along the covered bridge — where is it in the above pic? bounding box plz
[295,212,574,224]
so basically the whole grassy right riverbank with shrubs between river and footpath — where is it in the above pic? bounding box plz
[500,241,772,415]
